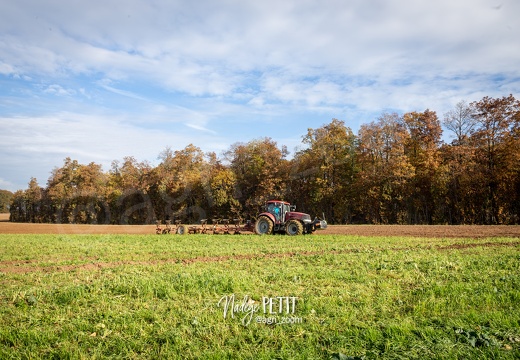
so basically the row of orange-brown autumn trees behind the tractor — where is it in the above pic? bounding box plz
[10,95,520,224]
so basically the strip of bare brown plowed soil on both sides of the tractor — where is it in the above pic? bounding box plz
[0,214,520,238]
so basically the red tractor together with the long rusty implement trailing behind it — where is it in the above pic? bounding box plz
[155,200,327,235]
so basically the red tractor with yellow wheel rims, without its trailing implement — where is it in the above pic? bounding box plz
[255,200,327,235]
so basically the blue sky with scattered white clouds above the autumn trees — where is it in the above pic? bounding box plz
[0,0,520,191]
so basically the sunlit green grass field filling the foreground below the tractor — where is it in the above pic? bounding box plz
[0,235,520,359]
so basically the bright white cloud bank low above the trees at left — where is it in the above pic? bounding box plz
[0,113,230,188]
